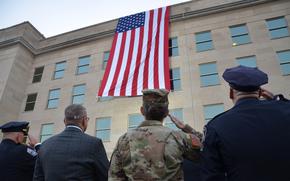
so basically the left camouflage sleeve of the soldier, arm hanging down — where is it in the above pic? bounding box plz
[108,134,128,181]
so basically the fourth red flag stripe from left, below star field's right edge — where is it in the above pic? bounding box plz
[132,26,144,96]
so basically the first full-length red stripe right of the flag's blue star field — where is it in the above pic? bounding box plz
[143,10,154,89]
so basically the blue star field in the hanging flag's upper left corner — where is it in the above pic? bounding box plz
[116,12,145,33]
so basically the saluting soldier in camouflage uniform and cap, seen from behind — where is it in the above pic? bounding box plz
[109,89,201,180]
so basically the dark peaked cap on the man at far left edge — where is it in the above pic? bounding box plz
[0,121,29,133]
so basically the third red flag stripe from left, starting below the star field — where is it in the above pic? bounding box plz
[120,29,135,96]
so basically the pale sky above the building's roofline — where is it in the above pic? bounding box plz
[0,0,188,37]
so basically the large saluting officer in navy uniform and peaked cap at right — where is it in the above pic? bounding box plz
[202,66,290,181]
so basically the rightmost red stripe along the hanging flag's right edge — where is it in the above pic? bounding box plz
[164,8,170,90]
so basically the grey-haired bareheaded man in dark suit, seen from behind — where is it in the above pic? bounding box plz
[33,104,109,181]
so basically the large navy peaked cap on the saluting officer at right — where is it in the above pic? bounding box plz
[223,65,268,92]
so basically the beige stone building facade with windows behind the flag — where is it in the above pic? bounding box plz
[0,0,290,155]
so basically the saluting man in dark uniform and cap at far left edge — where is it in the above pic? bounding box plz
[0,121,37,181]
